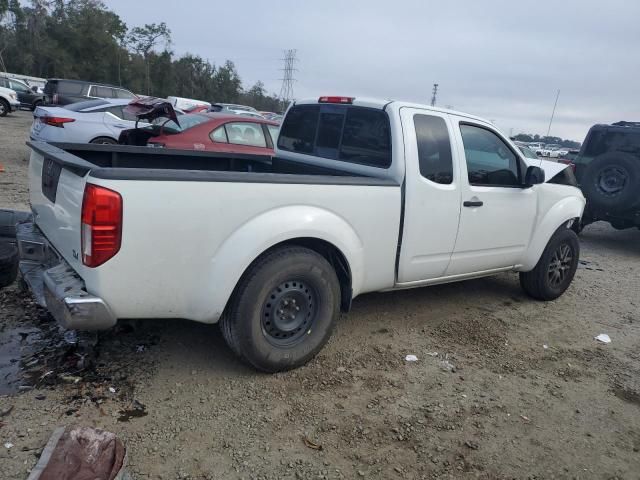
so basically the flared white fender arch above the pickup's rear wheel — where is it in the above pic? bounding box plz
[205,205,364,322]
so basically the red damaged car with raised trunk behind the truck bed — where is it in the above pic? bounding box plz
[120,98,280,155]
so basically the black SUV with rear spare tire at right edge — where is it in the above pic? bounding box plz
[573,122,640,230]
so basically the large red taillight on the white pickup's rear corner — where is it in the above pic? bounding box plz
[81,183,122,268]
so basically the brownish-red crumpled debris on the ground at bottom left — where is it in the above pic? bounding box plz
[27,427,126,480]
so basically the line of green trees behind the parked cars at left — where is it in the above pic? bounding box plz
[0,0,282,111]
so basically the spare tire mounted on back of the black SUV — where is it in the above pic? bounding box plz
[581,152,640,212]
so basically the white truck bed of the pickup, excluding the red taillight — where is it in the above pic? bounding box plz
[29,142,402,322]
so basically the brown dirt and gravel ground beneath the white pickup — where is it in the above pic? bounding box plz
[0,112,640,480]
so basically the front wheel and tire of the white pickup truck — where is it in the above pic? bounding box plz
[520,226,580,301]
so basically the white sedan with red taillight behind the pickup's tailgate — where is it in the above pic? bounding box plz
[31,99,146,144]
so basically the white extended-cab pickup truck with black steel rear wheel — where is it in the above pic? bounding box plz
[17,97,585,372]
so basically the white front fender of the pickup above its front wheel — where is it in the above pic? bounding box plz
[518,189,586,272]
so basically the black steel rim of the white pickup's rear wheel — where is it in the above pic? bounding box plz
[262,280,318,347]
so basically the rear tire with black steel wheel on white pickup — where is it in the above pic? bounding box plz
[220,246,340,373]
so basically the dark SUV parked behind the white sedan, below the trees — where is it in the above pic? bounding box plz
[44,78,137,105]
